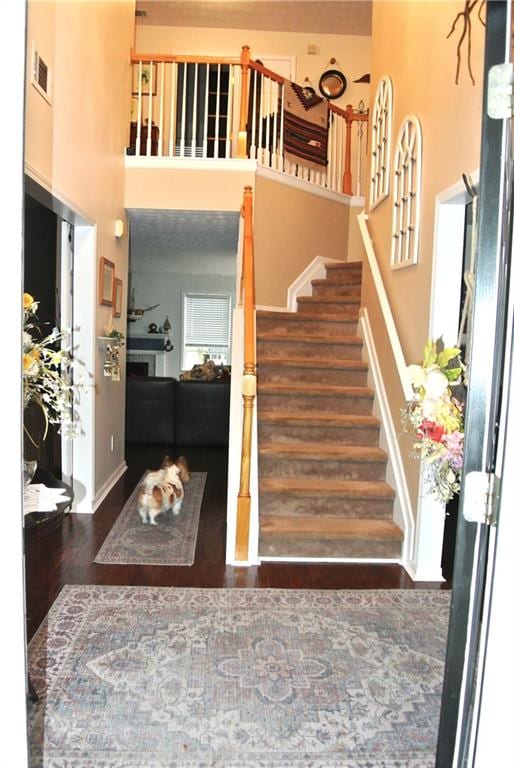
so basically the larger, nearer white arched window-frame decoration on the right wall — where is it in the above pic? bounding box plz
[391,115,422,269]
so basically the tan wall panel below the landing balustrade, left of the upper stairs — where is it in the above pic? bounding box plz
[254,176,349,307]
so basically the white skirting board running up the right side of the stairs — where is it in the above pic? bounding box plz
[360,307,415,572]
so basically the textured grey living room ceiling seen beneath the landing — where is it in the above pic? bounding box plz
[128,209,239,275]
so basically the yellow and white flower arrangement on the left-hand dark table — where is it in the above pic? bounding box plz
[22,293,88,445]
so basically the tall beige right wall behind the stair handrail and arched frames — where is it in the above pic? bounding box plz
[363,0,484,509]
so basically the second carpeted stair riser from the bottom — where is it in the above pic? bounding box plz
[259,493,393,520]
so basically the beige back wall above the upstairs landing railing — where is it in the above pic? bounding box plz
[136,25,371,114]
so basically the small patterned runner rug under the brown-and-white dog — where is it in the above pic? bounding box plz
[95,472,207,565]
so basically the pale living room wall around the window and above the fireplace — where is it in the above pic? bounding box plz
[128,270,236,379]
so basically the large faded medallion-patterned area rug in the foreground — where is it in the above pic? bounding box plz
[29,586,449,768]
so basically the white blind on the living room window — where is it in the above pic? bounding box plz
[184,293,232,346]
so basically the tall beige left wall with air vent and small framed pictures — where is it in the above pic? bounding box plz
[25,0,135,490]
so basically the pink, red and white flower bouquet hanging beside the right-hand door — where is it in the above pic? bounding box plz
[402,340,464,504]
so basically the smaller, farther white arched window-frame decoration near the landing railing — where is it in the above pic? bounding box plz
[369,75,393,211]
